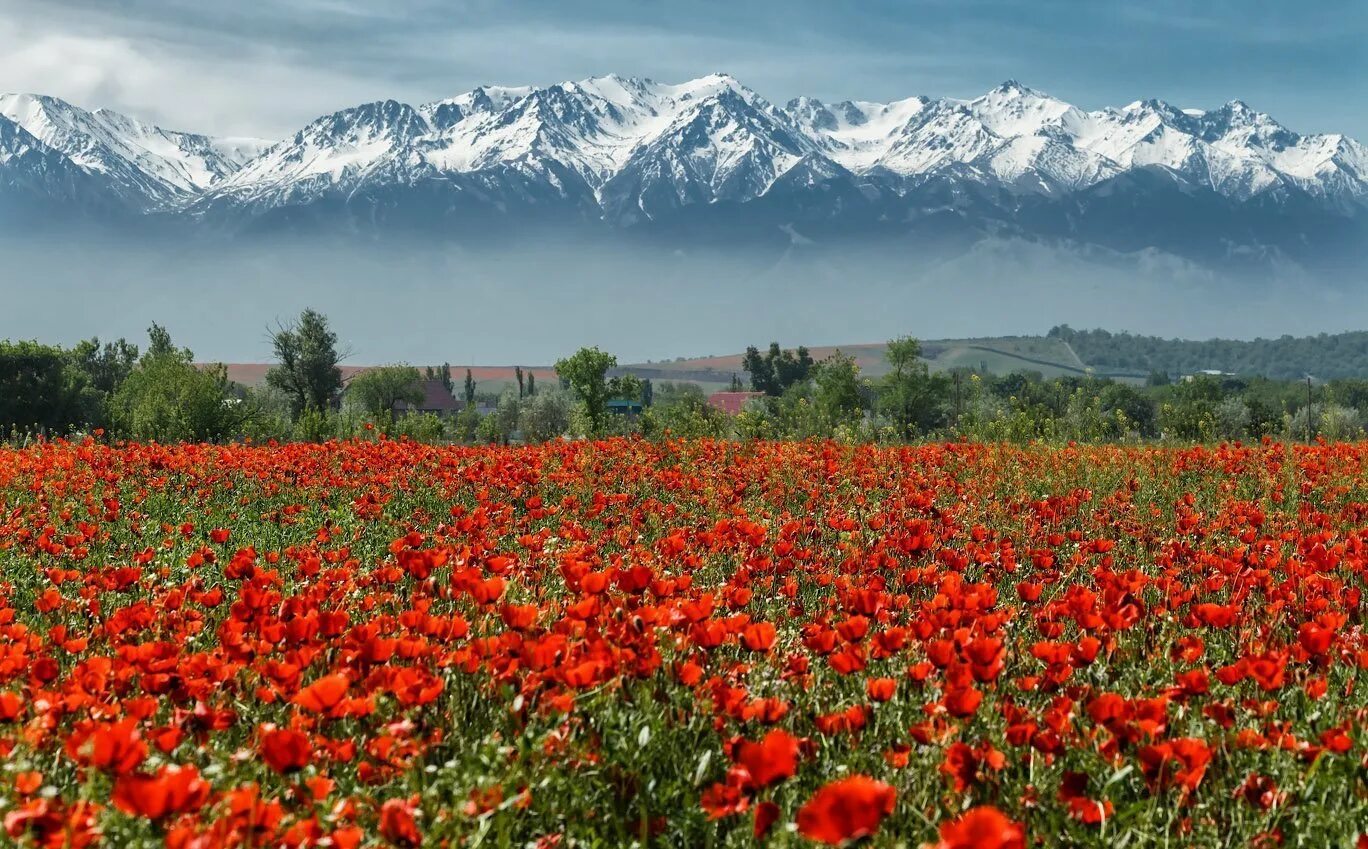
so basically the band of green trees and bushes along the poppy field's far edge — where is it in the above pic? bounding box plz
[0,310,1368,444]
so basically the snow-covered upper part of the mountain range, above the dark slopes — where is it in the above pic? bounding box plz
[0,72,1368,232]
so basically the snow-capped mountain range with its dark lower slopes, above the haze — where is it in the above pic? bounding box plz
[0,74,1368,272]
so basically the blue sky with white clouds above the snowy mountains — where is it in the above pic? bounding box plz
[0,0,1368,138]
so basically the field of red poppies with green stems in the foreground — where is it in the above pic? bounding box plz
[0,440,1368,849]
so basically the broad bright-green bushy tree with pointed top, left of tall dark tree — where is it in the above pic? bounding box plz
[111,324,252,442]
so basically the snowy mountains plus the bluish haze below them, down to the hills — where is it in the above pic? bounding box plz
[0,75,1368,361]
